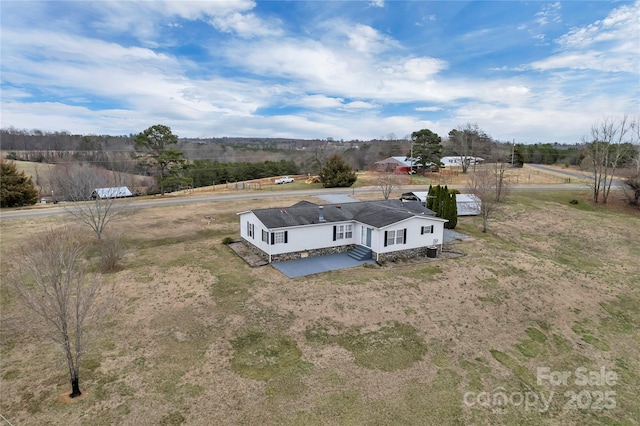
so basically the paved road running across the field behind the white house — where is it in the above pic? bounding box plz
[0,184,588,220]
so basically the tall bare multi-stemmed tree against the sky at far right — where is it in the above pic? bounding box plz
[583,115,637,204]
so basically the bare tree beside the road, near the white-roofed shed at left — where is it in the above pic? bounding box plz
[53,164,131,243]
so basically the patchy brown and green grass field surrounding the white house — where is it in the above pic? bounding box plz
[0,191,640,425]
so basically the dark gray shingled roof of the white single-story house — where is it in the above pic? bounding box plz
[252,200,435,229]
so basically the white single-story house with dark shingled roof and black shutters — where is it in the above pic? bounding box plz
[238,200,447,263]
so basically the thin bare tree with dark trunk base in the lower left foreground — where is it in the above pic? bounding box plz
[8,227,101,398]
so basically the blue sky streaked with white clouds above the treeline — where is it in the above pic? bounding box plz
[0,0,640,143]
